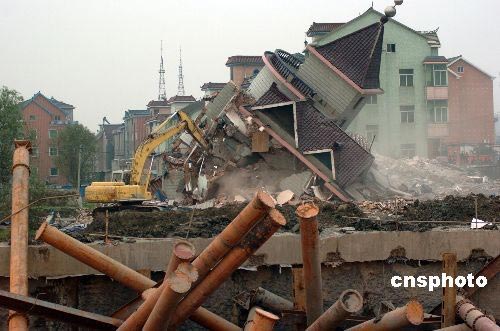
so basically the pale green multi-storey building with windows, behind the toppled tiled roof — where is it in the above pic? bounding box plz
[310,8,446,158]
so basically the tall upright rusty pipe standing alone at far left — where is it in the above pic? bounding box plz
[9,140,31,331]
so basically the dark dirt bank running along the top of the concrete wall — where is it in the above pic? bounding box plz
[77,195,500,241]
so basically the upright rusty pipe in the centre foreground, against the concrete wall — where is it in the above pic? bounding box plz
[296,203,323,326]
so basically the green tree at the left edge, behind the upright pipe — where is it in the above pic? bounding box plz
[0,86,24,189]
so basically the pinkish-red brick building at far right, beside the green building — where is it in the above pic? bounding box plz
[446,56,495,164]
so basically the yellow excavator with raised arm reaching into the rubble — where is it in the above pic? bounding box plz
[85,111,208,213]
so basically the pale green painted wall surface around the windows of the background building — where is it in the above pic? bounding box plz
[316,10,436,157]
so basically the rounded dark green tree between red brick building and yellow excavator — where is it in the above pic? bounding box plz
[56,124,97,186]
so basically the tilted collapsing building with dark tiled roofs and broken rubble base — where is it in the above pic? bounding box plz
[156,22,384,201]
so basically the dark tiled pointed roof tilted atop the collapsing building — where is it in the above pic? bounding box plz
[312,22,384,89]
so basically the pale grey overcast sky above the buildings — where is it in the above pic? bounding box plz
[0,0,500,130]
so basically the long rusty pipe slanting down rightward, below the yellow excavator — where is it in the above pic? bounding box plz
[35,222,156,293]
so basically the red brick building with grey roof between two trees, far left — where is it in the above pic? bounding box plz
[20,92,75,185]
